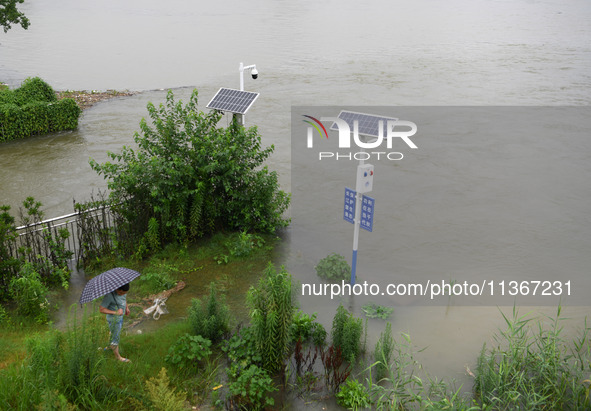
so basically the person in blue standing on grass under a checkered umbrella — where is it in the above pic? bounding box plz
[80,267,140,362]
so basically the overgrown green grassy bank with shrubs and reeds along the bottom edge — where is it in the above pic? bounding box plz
[0,233,591,410]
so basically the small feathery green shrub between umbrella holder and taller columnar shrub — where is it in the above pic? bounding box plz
[189,282,230,343]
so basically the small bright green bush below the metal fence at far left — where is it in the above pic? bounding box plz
[10,263,49,324]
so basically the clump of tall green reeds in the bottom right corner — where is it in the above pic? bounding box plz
[474,307,591,410]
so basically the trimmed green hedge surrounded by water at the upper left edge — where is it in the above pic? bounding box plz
[0,77,82,142]
